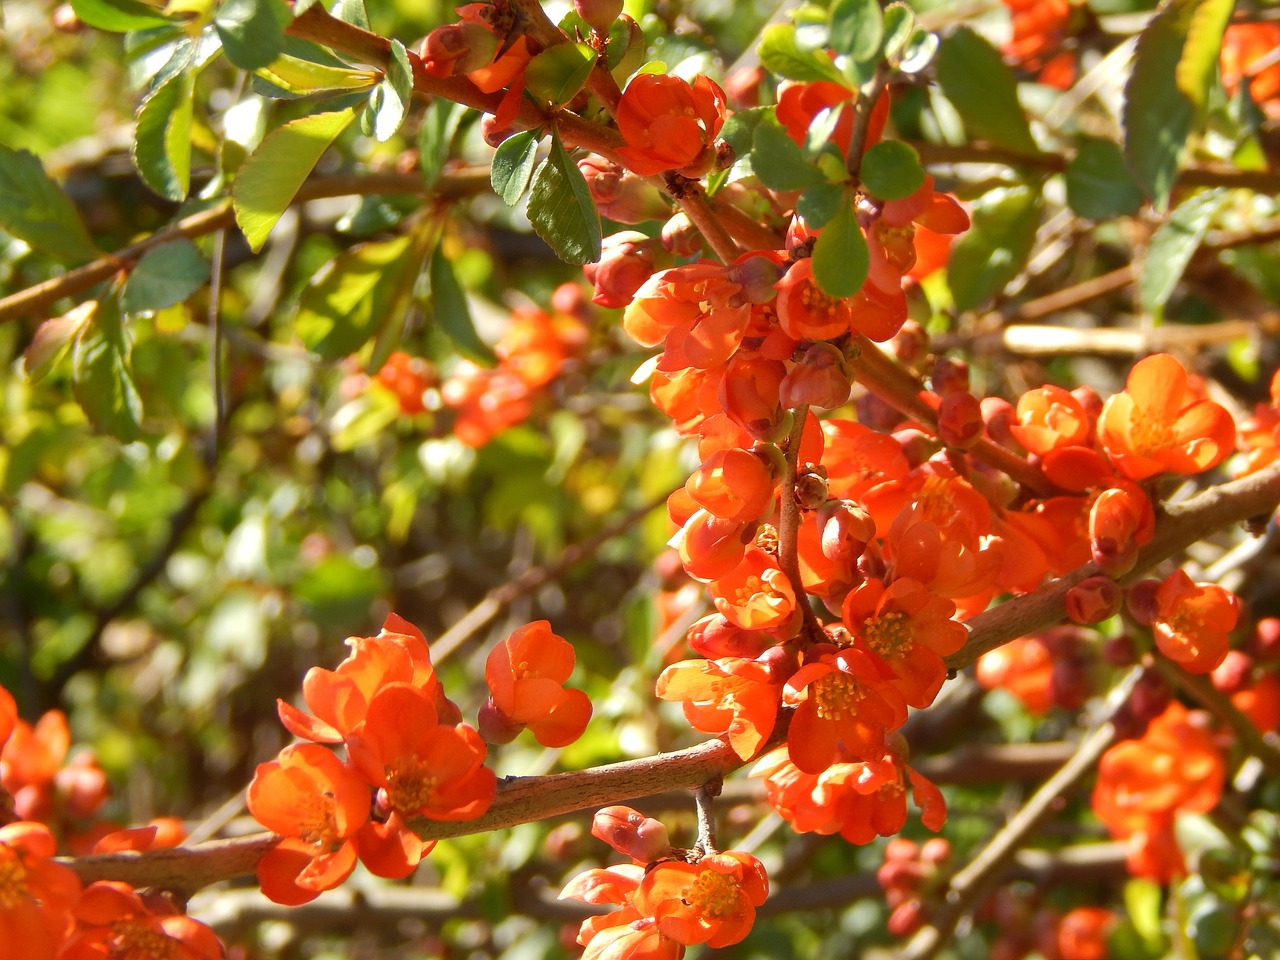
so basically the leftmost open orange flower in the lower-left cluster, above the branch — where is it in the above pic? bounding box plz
[246,744,370,906]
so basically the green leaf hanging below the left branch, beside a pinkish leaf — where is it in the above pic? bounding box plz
[72,300,142,443]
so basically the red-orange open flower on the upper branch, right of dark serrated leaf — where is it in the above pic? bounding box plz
[617,73,724,177]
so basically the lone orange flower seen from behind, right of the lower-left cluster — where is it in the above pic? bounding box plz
[484,620,591,746]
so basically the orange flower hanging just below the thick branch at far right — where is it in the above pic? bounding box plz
[1151,570,1240,673]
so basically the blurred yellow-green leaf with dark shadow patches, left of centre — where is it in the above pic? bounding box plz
[293,236,422,361]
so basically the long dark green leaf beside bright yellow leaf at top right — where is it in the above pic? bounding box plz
[1121,0,1201,211]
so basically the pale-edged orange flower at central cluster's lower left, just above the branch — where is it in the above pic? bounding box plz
[655,657,782,760]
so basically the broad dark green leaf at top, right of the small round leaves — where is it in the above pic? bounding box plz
[937,27,1039,154]
